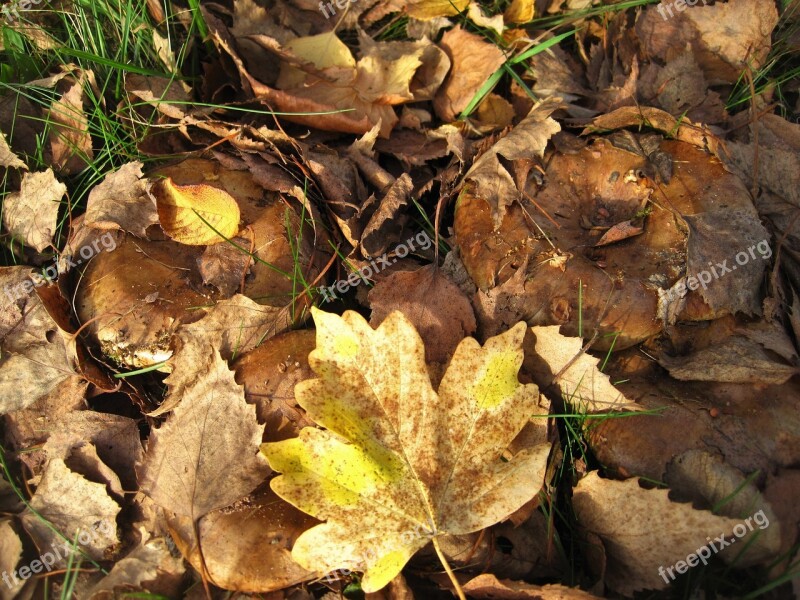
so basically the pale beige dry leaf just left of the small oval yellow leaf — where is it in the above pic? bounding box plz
[85,162,158,238]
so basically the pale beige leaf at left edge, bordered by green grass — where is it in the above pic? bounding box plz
[3,169,67,252]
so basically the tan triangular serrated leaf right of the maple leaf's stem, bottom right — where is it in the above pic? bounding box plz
[573,471,776,596]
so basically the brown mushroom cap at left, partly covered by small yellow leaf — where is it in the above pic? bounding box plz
[75,159,321,367]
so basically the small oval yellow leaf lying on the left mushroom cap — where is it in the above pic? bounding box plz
[151,177,239,246]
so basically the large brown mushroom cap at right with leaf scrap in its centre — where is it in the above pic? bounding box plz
[454,138,757,349]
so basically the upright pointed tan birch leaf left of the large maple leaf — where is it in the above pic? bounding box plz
[137,350,268,520]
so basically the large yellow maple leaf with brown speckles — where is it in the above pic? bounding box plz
[261,309,550,592]
